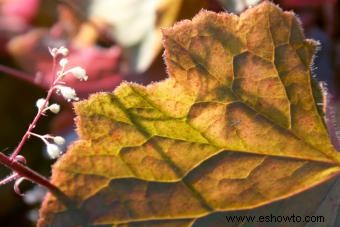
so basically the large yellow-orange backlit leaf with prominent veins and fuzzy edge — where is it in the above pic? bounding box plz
[39,2,340,226]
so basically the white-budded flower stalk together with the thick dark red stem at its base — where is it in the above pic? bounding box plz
[0,47,88,200]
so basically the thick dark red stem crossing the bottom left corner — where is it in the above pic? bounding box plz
[0,152,73,207]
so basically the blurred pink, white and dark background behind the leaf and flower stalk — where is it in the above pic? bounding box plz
[0,0,340,227]
